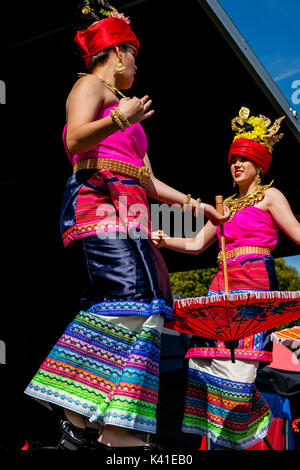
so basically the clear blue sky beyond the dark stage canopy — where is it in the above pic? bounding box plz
[219,0,300,274]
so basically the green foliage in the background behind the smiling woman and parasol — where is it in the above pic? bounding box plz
[170,255,300,330]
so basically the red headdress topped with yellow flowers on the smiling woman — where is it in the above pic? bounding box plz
[228,108,285,173]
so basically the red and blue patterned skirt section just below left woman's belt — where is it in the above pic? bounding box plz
[61,170,151,250]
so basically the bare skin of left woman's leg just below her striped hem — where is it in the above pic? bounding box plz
[98,425,149,447]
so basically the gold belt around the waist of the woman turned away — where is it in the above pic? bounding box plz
[73,158,150,187]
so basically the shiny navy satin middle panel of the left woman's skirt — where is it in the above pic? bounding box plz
[67,234,173,318]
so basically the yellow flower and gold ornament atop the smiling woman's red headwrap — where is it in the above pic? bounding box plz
[231,107,285,152]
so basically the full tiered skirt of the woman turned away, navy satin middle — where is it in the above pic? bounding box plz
[25,170,173,433]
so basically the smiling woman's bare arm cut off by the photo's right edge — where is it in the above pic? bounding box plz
[265,188,300,245]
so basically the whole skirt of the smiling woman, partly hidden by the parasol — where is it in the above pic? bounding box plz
[182,257,278,450]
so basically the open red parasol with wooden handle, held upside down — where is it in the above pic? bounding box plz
[165,196,300,362]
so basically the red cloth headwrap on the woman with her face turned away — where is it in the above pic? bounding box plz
[74,10,139,68]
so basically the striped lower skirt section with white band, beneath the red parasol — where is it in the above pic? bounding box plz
[182,359,272,450]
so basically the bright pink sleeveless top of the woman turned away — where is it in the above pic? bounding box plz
[63,102,148,167]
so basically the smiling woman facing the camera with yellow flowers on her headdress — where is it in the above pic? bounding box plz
[153,108,300,450]
